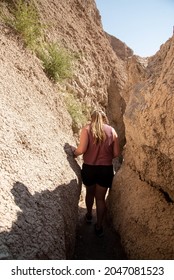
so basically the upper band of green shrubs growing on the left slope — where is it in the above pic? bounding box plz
[2,0,74,82]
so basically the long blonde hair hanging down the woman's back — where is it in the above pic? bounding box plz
[91,110,108,144]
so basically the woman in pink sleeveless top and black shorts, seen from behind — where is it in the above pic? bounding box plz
[72,110,119,237]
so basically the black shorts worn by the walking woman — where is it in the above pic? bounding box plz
[81,163,114,188]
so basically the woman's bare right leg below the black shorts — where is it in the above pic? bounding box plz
[95,185,107,228]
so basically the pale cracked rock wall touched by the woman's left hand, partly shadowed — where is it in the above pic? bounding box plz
[0,26,81,259]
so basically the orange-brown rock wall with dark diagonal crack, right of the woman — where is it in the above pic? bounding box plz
[110,37,174,259]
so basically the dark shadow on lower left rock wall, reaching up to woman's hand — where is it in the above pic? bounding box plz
[0,143,81,259]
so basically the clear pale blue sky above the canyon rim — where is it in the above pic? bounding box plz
[95,0,174,57]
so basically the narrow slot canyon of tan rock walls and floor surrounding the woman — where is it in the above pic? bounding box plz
[0,0,174,260]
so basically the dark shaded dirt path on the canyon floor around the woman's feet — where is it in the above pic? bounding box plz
[74,188,127,260]
